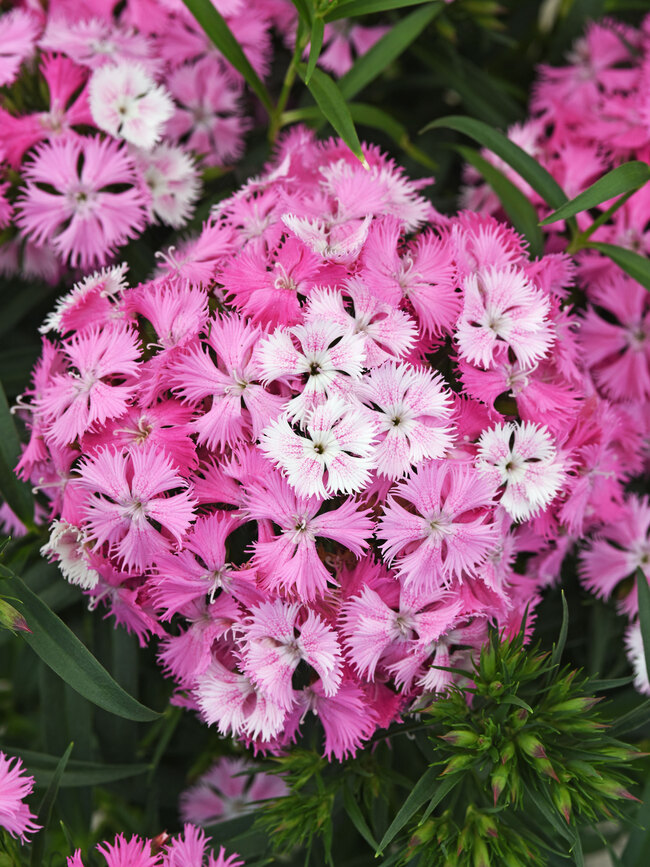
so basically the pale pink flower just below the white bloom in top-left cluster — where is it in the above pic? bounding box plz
[132,142,201,229]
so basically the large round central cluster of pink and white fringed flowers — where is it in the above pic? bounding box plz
[18,128,642,759]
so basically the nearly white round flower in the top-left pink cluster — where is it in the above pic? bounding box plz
[89,60,174,150]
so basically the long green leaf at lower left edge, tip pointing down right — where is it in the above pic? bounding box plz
[0,567,160,722]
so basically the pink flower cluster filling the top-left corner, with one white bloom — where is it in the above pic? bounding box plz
[0,0,290,282]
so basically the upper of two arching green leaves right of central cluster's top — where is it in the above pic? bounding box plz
[422,115,575,225]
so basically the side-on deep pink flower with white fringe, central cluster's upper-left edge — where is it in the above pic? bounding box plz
[38,262,128,334]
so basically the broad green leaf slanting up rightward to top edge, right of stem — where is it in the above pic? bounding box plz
[339,0,445,99]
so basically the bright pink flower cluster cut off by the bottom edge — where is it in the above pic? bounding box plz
[66,825,244,867]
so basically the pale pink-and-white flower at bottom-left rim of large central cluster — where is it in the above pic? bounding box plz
[193,660,286,741]
